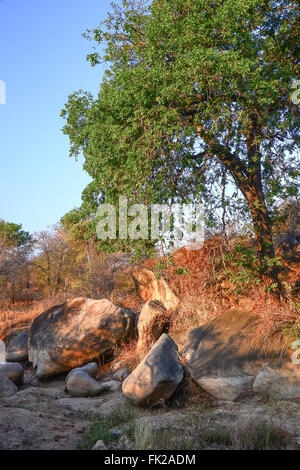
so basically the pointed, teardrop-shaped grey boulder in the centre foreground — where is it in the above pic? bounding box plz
[122,333,183,406]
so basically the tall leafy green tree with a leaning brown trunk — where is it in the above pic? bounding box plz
[62,0,300,280]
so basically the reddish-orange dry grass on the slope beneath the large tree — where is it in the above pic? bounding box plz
[144,236,300,343]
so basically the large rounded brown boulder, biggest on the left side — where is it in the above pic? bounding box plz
[28,298,136,378]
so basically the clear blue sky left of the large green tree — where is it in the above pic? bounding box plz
[0,0,118,232]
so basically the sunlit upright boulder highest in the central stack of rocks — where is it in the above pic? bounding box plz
[132,266,179,312]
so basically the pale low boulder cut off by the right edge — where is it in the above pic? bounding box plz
[253,365,300,400]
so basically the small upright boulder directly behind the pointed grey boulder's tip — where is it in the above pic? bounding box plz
[137,300,168,350]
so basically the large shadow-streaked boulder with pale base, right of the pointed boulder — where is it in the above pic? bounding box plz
[184,309,286,400]
